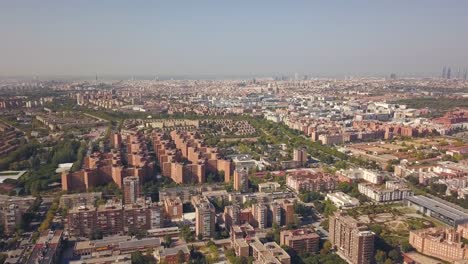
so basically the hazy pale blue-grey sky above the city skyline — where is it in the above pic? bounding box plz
[0,0,468,76]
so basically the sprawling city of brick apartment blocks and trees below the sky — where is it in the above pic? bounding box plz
[0,75,468,264]
